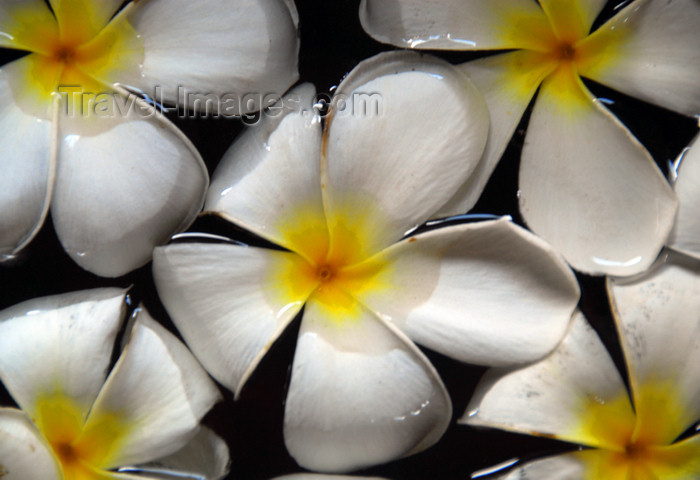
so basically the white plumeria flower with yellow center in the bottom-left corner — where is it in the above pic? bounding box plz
[0,289,228,480]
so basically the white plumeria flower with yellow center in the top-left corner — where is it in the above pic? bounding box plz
[0,0,298,276]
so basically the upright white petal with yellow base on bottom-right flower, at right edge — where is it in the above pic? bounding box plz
[608,256,700,443]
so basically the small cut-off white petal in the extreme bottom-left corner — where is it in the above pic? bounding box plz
[0,408,63,480]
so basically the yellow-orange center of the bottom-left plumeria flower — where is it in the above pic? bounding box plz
[34,394,127,480]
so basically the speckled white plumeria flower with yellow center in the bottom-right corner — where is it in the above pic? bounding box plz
[462,256,700,480]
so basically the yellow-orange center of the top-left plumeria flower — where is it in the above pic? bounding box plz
[4,0,143,111]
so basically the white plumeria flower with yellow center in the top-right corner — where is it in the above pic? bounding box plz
[360,0,700,275]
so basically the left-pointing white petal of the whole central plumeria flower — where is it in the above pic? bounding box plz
[153,243,310,396]
